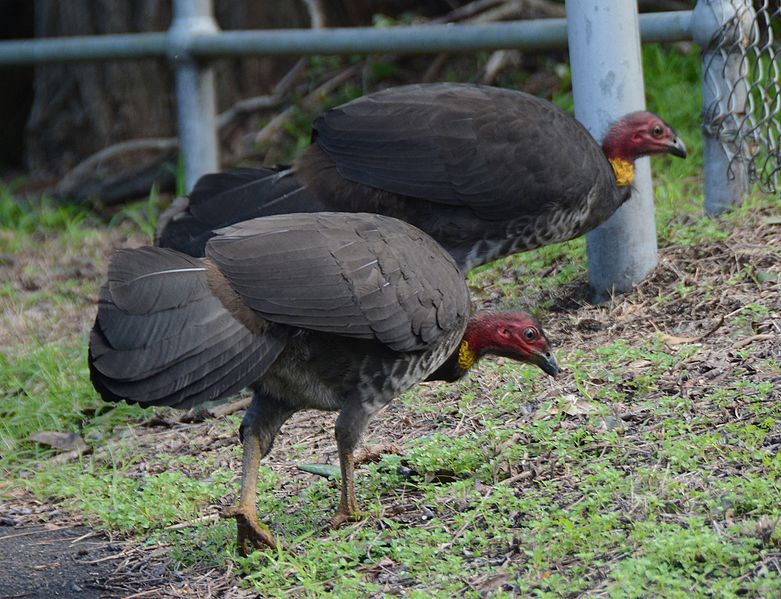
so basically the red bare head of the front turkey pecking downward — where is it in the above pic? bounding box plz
[464,312,559,376]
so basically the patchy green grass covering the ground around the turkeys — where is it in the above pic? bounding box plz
[0,46,781,597]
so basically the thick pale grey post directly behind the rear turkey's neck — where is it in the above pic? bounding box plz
[566,0,657,302]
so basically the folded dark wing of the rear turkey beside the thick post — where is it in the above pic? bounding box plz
[312,83,610,221]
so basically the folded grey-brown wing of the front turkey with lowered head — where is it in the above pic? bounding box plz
[206,213,469,351]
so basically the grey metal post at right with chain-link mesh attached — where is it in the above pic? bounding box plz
[691,0,754,214]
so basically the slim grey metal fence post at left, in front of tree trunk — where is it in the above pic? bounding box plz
[168,0,219,192]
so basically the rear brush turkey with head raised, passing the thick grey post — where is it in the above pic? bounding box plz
[158,83,686,272]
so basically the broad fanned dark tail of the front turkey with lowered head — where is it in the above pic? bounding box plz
[88,248,285,408]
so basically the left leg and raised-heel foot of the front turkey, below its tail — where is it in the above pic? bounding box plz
[222,391,293,555]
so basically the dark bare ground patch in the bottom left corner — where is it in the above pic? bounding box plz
[0,497,254,599]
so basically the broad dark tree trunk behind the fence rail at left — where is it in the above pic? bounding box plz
[25,0,309,180]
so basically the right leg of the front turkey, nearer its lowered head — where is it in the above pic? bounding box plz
[331,400,371,528]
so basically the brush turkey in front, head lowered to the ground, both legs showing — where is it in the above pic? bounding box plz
[89,213,558,552]
